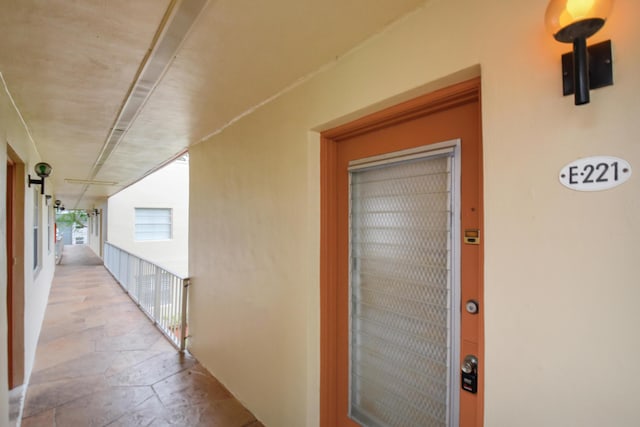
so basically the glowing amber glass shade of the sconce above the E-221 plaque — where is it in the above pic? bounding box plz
[545,0,613,43]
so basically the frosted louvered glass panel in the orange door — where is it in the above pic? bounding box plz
[349,153,453,427]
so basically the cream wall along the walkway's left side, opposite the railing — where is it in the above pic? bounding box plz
[0,74,55,425]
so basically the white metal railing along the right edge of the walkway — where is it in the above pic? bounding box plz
[104,243,189,351]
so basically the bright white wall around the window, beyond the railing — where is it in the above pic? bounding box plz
[106,161,189,277]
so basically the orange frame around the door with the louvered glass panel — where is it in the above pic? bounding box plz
[320,78,485,427]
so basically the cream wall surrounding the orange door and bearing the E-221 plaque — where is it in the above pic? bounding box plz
[189,0,640,427]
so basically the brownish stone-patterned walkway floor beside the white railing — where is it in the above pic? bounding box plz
[22,246,263,427]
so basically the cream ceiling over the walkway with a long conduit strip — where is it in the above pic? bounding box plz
[0,0,425,209]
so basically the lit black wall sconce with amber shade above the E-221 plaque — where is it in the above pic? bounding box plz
[545,0,613,105]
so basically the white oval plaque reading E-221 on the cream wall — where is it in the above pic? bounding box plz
[560,156,631,191]
